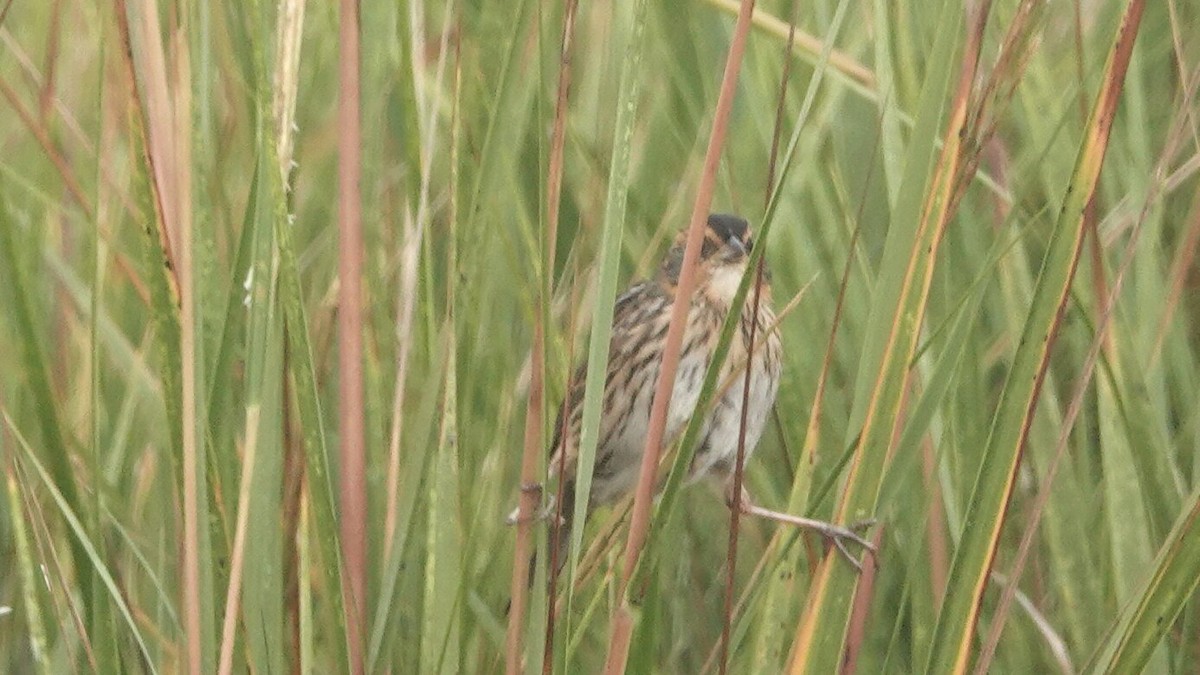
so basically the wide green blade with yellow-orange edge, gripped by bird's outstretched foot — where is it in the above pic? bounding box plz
[791,2,962,673]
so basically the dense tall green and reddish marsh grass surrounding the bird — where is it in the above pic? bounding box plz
[0,0,1200,673]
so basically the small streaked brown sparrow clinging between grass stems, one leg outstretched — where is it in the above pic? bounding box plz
[509,214,874,583]
